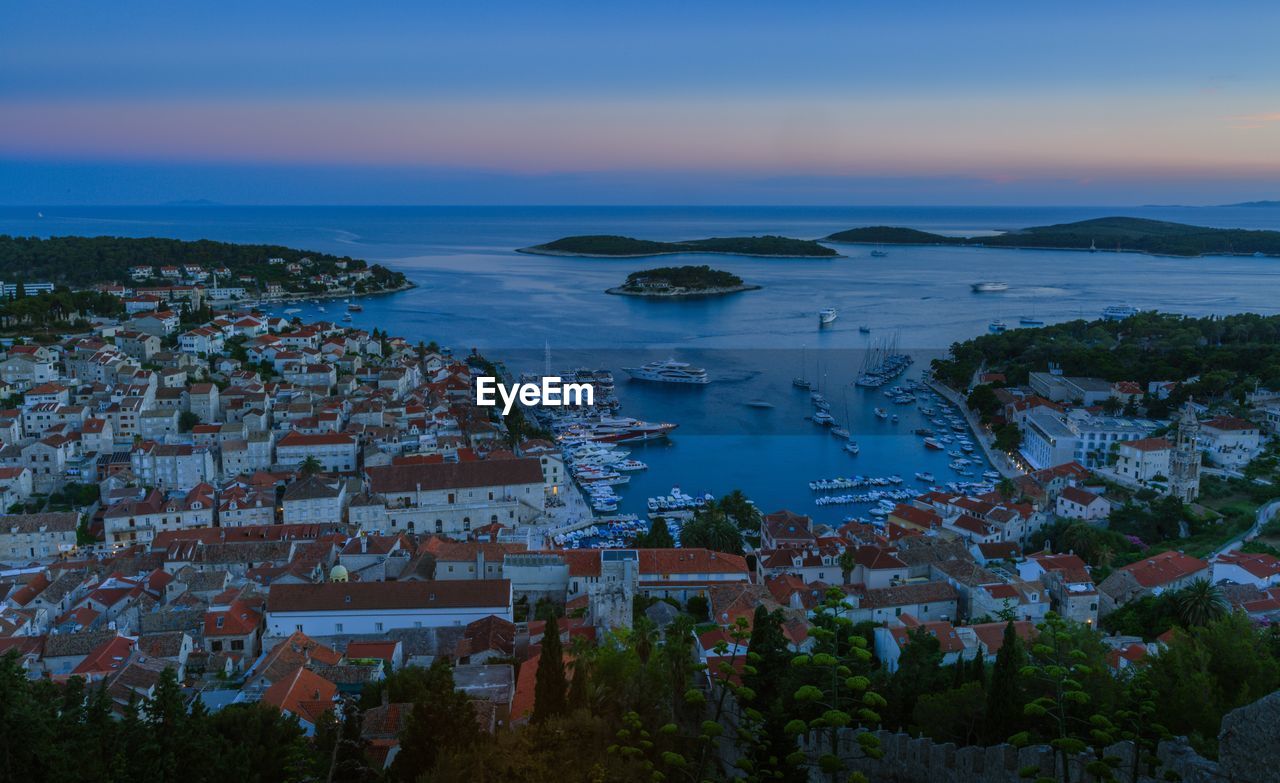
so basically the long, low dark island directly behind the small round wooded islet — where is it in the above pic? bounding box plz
[517,234,840,258]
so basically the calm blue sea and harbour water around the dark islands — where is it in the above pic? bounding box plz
[0,206,1280,523]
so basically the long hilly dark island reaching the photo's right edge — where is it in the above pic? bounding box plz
[827,218,1280,256]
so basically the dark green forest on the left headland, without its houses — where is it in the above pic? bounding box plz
[0,235,406,292]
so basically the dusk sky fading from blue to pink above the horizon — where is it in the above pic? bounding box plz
[0,0,1280,205]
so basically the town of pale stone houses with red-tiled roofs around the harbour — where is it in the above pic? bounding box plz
[0,267,1280,779]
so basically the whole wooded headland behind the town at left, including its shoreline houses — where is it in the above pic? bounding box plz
[0,235,412,298]
